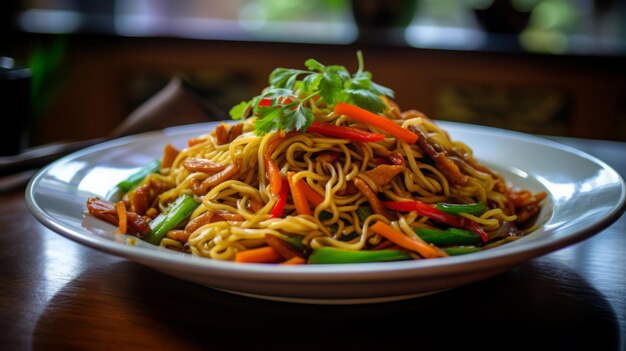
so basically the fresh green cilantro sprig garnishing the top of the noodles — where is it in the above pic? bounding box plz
[230,51,394,135]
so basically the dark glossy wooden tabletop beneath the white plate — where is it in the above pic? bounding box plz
[0,138,626,351]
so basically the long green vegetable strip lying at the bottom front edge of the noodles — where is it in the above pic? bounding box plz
[308,247,411,264]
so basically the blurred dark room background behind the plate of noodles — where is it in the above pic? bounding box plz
[0,0,626,154]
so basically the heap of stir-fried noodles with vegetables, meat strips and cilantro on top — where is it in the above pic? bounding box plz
[87,53,546,264]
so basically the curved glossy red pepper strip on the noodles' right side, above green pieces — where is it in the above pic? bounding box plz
[383,201,489,242]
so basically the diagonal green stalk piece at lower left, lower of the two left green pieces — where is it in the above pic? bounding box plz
[146,194,200,245]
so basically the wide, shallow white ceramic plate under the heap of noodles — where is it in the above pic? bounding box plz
[26,122,626,303]
